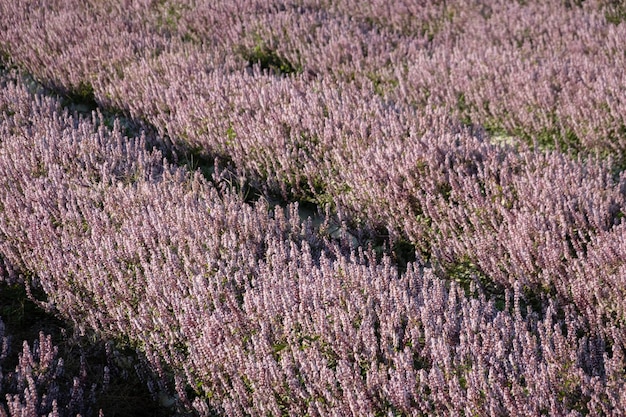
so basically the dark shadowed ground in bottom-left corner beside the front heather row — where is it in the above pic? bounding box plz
[0,282,172,417]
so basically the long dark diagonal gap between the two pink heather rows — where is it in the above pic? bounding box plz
[0,56,564,313]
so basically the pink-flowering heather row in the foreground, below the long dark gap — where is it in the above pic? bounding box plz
[0,74,625,415]
